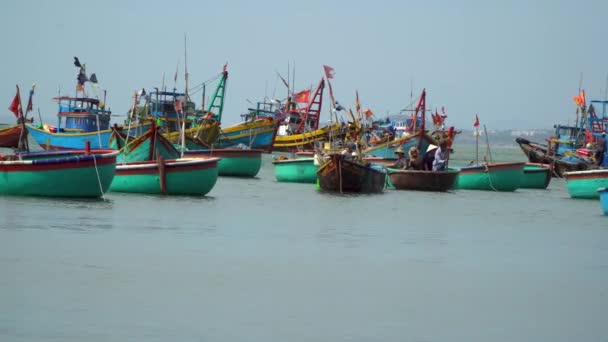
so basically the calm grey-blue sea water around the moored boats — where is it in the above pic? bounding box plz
[0,146,608,342]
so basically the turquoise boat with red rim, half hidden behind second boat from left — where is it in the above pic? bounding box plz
[184,148,264,177]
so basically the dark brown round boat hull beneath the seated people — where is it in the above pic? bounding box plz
[388,169,460,191]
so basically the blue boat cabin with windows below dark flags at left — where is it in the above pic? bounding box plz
[54,96,111,133]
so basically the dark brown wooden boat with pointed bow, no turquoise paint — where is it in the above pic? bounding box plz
[317,154,386,193]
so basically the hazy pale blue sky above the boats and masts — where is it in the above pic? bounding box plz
[0,0,608,130]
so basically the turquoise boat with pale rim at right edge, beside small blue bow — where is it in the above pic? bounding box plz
[564,169,608,198]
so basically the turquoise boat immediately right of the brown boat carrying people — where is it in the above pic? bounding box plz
[454,162,525,191]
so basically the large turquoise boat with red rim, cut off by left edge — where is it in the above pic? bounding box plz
[0,150,118,197]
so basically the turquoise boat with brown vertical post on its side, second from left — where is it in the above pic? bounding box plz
[110,158,219,196]
